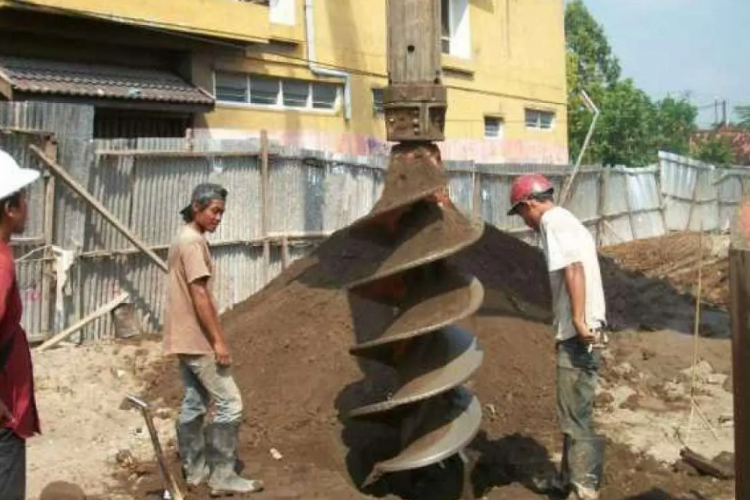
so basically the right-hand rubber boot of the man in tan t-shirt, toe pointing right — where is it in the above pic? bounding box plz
[206,423,263,497]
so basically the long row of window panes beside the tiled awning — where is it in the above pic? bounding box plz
[215,71,341,110]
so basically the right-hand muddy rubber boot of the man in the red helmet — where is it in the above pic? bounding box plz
[570,436,606,500]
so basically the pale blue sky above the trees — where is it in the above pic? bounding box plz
[572,0,750,126]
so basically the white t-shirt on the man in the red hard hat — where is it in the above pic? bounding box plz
[540,207,606,341]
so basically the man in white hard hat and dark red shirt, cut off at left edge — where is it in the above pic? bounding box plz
[0,150,40,500]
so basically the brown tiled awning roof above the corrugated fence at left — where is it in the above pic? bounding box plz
[0,56,214,109]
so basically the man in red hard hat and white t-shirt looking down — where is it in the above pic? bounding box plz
[508,174,606,500]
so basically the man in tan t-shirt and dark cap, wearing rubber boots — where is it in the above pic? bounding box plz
[164,184,263,495]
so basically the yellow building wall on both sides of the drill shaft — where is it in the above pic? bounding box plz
[193,0,568,163]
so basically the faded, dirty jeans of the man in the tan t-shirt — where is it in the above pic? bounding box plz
[179,354,242,424]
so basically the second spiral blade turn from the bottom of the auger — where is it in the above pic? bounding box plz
[350,326,483,419]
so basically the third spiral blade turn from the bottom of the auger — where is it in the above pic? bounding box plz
[349,268,484,361]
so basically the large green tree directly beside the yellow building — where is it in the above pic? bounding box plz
[565,0,698,166]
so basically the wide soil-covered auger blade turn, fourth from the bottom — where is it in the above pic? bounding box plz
[316,203,484,288]
